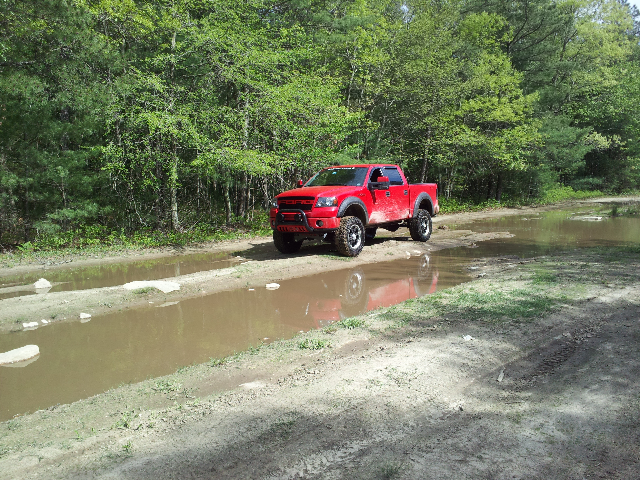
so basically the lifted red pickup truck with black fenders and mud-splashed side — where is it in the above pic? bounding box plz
[269,165,440,257]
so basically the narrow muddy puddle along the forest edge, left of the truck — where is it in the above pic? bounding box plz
[0,253,242,300]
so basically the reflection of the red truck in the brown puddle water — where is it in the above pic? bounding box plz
[277,255,438,328]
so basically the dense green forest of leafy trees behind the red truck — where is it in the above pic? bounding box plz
[0,0,640,245]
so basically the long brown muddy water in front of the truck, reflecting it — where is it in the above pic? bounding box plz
[0,205,640,421]
